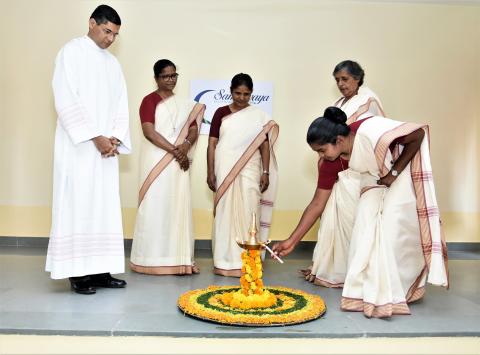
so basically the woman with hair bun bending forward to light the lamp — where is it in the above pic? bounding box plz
[307,107,448,317]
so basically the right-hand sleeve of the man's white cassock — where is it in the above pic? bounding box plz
[112,68,132,154]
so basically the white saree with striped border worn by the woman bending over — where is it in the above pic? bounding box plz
[332,117,448,317]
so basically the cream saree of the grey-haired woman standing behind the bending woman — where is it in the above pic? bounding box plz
[306,86,384,287]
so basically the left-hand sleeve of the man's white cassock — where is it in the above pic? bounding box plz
[52,47,100,144]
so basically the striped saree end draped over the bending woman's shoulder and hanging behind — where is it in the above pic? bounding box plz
[375,118,448,287]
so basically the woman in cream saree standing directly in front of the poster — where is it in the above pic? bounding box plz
[207,73,278,277]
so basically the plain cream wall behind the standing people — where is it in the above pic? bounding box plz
[0,0,480,242]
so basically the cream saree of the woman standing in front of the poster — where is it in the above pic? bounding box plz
[212,106,278,276]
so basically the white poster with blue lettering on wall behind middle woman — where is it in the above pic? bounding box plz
[190,80,273,134]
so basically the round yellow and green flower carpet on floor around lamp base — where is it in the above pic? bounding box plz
[178,286,326,327]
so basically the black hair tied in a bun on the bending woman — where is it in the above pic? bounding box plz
[307,106,350,145]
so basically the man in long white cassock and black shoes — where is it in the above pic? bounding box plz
[46,5,131,294]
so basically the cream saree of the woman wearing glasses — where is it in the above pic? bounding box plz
[130,96,205,275]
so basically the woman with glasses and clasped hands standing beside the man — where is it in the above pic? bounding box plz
[130,59,205,275]
